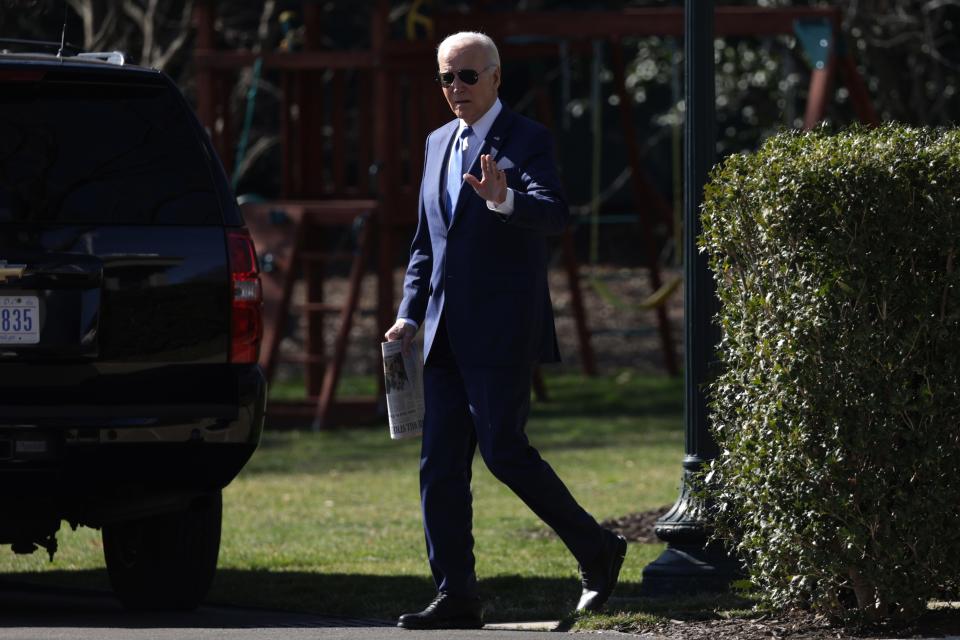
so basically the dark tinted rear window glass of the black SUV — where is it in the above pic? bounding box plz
[0,82,222,224]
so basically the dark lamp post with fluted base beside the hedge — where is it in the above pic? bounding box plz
[641,0,737,596]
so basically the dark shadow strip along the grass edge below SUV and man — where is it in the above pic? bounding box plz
[0,568,639,627]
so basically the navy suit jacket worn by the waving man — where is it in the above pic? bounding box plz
[397,107,570,366]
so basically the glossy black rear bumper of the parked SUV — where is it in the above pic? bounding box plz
[0,365,267,528]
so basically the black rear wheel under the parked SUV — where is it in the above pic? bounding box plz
[103,491,223,610]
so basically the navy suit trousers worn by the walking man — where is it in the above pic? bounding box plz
[420,316,603,596]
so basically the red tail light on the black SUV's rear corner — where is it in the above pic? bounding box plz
[227,229,263,364]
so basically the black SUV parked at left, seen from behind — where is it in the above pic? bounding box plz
[0,41,266,609]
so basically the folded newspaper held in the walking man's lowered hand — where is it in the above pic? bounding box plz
[381,340,423,440]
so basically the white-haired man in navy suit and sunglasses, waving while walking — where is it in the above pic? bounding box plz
[385,32,627,629]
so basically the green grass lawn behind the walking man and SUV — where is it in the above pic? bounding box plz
[0,371,683,622]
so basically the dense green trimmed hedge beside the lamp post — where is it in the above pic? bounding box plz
[701,125,960,620]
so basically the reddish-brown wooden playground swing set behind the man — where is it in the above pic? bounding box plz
[188,0,878,428]
